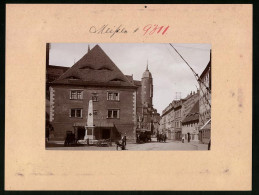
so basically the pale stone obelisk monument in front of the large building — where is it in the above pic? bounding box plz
[84,100,95,140]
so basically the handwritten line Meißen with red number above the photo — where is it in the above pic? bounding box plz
[89,24,170,38]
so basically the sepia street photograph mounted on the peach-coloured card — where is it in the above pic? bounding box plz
[45,43,211,151]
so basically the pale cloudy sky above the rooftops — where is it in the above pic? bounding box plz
[49,43,211,114]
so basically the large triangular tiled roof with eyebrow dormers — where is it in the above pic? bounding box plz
[53,45,135,87]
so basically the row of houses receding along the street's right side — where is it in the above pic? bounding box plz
[159,54,211,143]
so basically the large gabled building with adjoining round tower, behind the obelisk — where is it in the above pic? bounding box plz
[46,44,160,140]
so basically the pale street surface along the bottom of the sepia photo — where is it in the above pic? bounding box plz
[46,140,208,151]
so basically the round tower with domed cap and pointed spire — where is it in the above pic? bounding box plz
[141,63,153,108]
